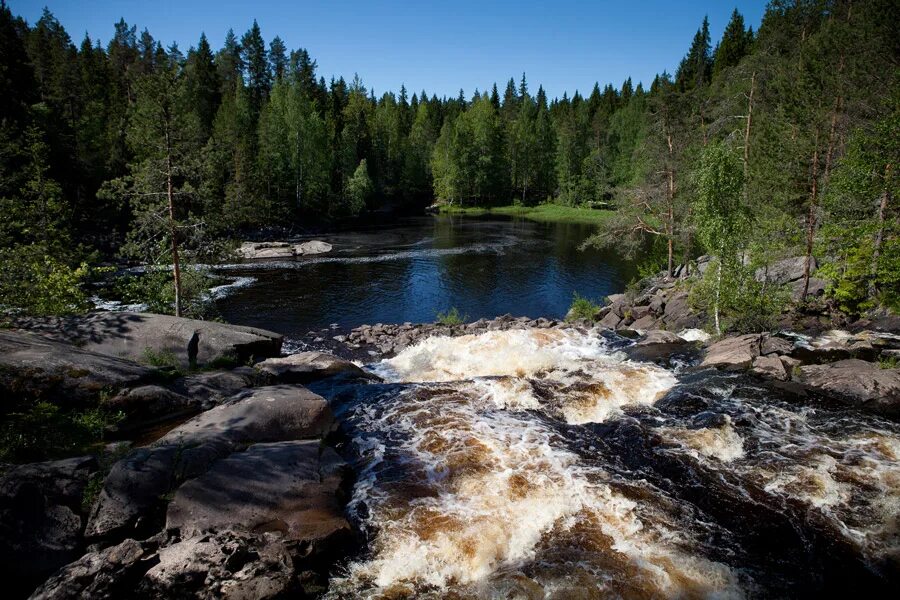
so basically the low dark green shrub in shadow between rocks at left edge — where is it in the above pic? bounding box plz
[0,401,124,462]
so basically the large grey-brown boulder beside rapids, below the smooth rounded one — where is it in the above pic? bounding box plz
[166,440,351,552]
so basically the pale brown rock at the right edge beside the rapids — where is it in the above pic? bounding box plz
[798,359,900,416]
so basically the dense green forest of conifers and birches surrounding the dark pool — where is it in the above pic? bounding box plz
[0,0,900,322]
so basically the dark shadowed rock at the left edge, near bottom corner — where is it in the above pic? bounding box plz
[0,456,98,597]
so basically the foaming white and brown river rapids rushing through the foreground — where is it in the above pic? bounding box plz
[316,329,900,599]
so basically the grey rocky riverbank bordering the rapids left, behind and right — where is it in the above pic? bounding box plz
[0,302,900,598]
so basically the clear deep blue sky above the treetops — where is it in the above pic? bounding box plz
[7,0,766,97]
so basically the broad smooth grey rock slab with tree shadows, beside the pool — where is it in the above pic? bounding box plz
[16,312,283,367]
